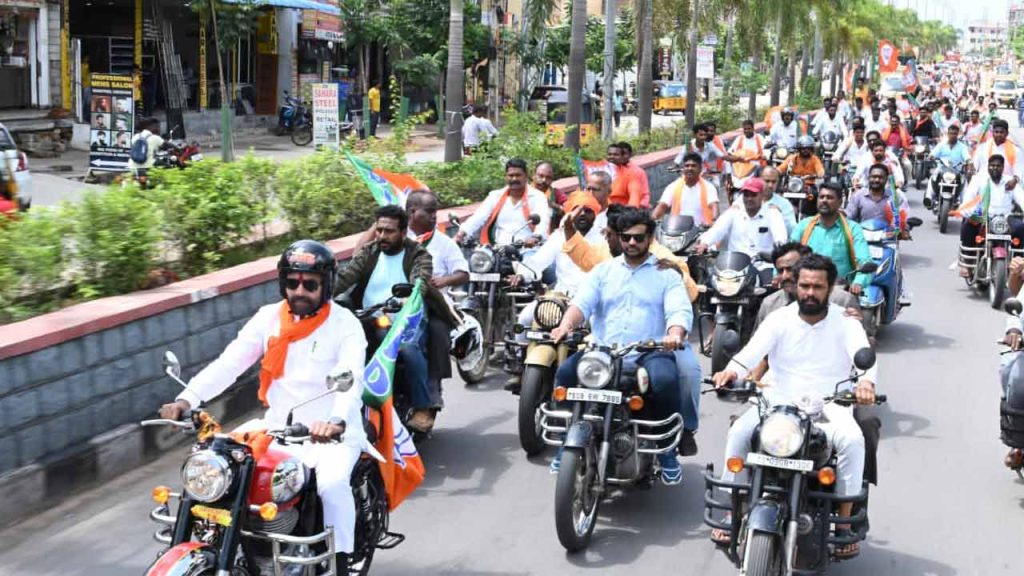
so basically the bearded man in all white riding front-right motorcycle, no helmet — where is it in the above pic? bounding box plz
[712,254,877,558]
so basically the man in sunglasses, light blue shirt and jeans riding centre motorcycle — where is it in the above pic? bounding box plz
[552,211,693,485]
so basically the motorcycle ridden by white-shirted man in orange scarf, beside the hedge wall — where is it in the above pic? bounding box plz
[452,214,541,383]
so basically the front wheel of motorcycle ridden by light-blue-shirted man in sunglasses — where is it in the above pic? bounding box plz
[555,447,601,552]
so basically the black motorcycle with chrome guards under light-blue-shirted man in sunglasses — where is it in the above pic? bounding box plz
[541,341,683,551]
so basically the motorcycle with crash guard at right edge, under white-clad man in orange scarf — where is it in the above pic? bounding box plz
[958,214,1024,310]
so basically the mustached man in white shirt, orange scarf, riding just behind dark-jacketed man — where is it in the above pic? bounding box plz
[455,158,551,245]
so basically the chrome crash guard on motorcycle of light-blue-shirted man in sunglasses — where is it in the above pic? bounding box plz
[541,402,683,484]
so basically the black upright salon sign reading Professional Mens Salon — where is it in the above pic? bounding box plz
[89,74,135,172]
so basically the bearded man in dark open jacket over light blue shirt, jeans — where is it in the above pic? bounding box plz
[334,205,459,434]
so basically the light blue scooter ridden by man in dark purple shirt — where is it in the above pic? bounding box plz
[860,216,924,327]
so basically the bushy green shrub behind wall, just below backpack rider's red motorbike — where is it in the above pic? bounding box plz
[144,159,269,274]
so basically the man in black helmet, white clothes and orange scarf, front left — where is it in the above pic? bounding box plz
[160,240,367,566]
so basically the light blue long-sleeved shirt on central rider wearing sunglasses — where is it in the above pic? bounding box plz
[572,255,693,344]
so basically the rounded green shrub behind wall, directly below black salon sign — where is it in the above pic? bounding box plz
[68,184,162,298]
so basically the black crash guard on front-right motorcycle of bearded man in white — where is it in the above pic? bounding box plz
[703,464,869,574]
